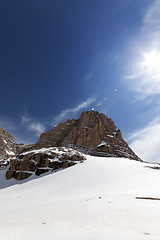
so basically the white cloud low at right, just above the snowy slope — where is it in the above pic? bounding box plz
[127,117,160,163]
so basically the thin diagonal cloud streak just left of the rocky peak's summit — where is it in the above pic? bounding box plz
[51,98,96,125]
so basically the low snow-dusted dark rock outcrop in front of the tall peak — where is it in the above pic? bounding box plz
[6,148,85,180]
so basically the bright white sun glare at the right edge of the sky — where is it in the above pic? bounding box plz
[142,50,160,72]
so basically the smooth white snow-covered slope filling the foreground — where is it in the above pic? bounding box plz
[0,156,160,240]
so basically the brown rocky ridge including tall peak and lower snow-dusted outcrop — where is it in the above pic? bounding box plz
[0,111,141,180]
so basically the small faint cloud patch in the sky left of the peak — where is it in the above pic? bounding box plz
[21,114,46,136]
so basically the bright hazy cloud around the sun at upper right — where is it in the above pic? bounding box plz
[126,0,160,100]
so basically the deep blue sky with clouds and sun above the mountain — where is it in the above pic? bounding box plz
[0,0,160,159]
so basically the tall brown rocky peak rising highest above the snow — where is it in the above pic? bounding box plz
[35,111,140,161]
